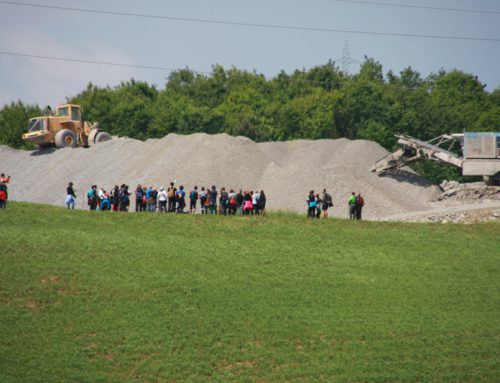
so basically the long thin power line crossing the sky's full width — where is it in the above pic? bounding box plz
[0,0,500,42]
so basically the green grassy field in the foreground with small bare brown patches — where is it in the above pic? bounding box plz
[0,203,500,383]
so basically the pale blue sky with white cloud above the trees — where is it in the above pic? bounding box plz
[0,0,500,107]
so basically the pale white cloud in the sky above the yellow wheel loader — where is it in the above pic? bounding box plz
[0,23,141,107]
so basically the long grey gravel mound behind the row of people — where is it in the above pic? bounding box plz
[0,133,439,218]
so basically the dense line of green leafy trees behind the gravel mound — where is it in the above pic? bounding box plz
[0,57,500,183]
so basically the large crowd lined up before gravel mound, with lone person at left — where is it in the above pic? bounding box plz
[69,182,266,215]
